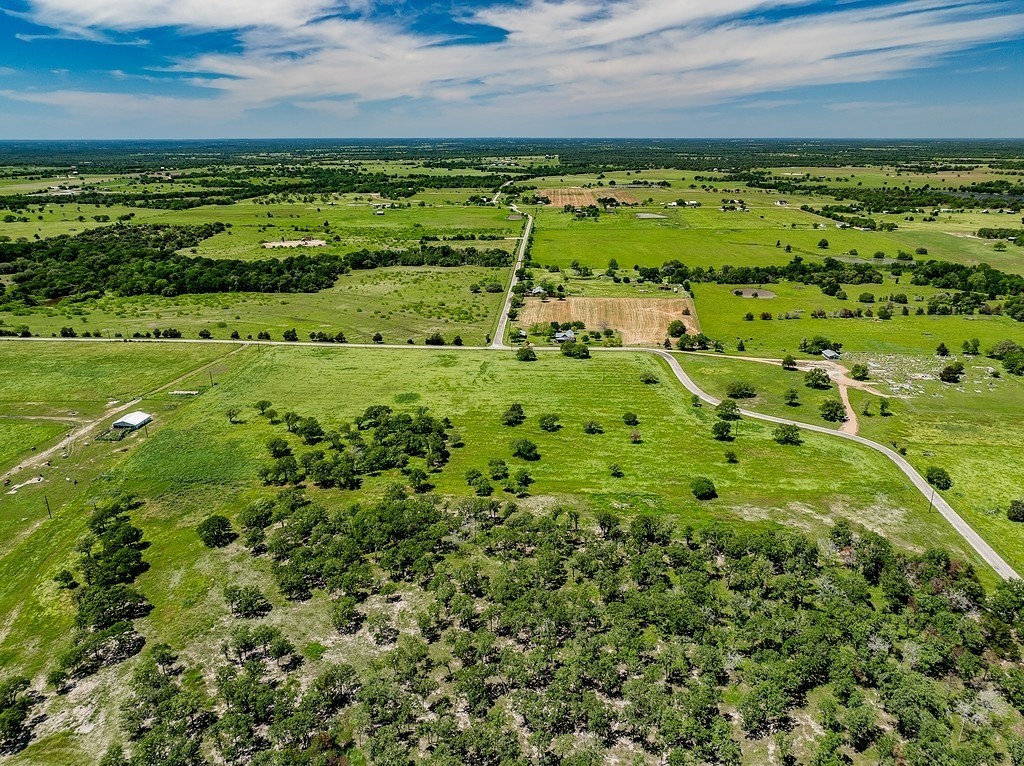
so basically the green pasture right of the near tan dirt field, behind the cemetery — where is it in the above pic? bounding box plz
[692,280,1024,356]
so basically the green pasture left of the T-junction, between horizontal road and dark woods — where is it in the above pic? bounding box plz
[0,266,509,345]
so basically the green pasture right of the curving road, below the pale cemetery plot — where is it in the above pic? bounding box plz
[850,364,1024,571]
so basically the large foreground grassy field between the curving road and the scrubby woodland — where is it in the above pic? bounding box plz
[0,343,1022,764]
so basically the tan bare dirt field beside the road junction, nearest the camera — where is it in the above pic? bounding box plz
[519,298,700,346]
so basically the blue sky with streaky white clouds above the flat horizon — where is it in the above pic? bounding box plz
[0,0,1024,138]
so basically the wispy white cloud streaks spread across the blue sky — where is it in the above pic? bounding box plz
[8,0,1024,132]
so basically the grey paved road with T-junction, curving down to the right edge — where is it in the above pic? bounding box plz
[0,335,1020,580]
